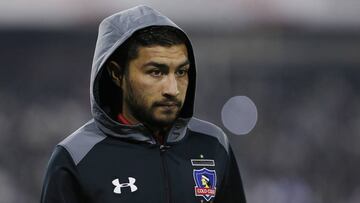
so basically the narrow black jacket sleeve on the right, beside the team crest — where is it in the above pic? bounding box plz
[215,146,246,203]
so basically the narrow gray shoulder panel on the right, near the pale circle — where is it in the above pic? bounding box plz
[188,118,229,152]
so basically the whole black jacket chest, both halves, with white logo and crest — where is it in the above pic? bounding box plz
[74,136,222,203]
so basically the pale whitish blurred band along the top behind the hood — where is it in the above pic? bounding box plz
[0,0,360,28]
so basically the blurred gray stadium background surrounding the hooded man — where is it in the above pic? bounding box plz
[0,0,360,203]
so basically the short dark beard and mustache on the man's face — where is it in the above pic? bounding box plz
[123,80,182,128]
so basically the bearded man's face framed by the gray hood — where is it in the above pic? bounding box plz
[122,44,190,127]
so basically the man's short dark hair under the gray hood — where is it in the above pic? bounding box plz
[110,26,187,70]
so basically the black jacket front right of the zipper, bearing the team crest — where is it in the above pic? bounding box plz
[166,146,225,203]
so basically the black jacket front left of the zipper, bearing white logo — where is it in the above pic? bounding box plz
[79,144,164,203]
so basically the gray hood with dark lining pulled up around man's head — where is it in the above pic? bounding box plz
[90,6,196,143]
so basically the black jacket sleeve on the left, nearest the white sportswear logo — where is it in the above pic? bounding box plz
[40,146,84,203]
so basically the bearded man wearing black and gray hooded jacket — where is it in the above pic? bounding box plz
[41,6,245,203]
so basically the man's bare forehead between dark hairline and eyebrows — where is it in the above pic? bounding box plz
[137,44,188,63]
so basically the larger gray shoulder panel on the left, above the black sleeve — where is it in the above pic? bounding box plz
[58,120,106,165]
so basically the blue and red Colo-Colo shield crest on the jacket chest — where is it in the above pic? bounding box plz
[193,168,216,201]
